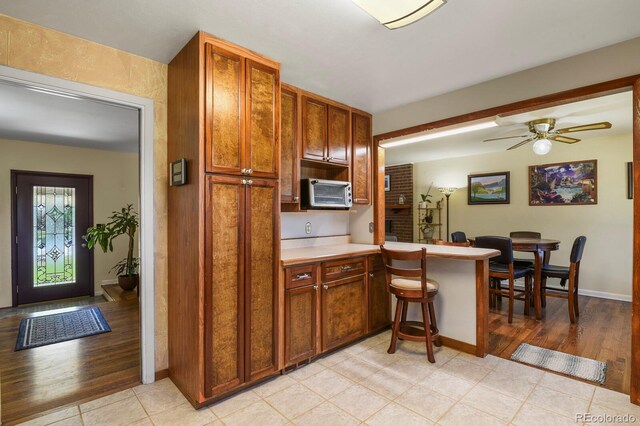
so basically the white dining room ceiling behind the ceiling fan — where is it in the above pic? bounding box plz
[384,91,633,165]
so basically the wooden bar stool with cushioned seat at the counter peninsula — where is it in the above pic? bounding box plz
[380,245,441,363]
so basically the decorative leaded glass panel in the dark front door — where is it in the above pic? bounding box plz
[33,186,76,287]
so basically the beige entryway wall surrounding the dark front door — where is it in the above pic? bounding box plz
[0,139,139,307]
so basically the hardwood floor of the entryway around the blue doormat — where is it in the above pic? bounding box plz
[0,300,140,425]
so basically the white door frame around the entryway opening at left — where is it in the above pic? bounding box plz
[0,65,161,384]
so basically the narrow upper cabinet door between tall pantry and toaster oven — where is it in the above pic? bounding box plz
[280,88,299,203]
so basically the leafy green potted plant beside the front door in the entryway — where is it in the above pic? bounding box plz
[82,204,140,291]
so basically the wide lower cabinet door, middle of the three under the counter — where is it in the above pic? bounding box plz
[321,275,368,352]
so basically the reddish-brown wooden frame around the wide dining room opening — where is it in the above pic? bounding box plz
[373,74,640,405]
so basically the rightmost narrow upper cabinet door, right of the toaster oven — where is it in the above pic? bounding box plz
[351,112,372,204]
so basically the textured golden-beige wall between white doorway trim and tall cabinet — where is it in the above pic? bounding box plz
[0,15,168,370]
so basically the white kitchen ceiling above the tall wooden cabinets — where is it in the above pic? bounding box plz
[0,0,640,113]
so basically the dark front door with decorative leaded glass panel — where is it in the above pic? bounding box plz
[11,171,93,306]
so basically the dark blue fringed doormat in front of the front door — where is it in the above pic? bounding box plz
[15,306,111,351]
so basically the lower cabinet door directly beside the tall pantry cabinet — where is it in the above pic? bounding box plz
[284,285,318,365]
